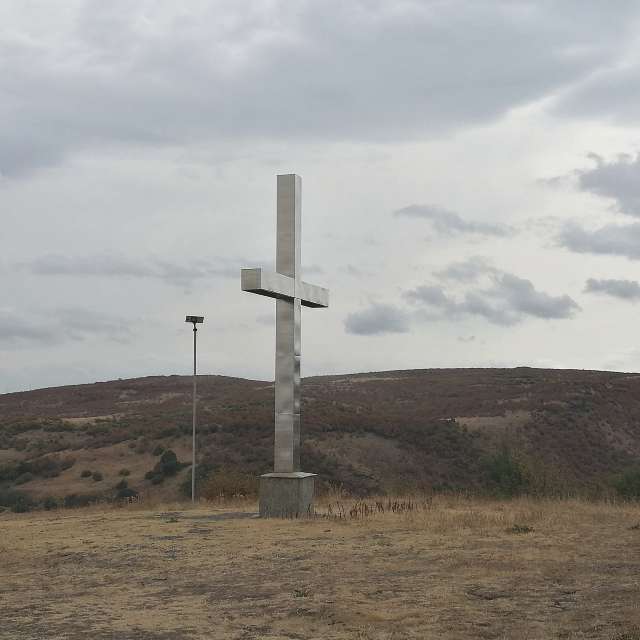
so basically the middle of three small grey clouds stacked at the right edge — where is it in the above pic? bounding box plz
[558,223,640,260]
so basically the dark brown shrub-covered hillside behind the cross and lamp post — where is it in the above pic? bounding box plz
[0,368,640,508]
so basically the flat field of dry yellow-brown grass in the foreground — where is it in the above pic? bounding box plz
[0,498,640,640]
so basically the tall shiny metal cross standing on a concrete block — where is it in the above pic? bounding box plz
[241,174,329,473]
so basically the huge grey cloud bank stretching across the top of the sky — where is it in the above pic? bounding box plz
[0,0,634,176]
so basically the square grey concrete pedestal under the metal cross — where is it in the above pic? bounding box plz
[260,471,316,518]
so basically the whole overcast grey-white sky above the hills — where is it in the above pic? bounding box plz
[0,0,640,392]
